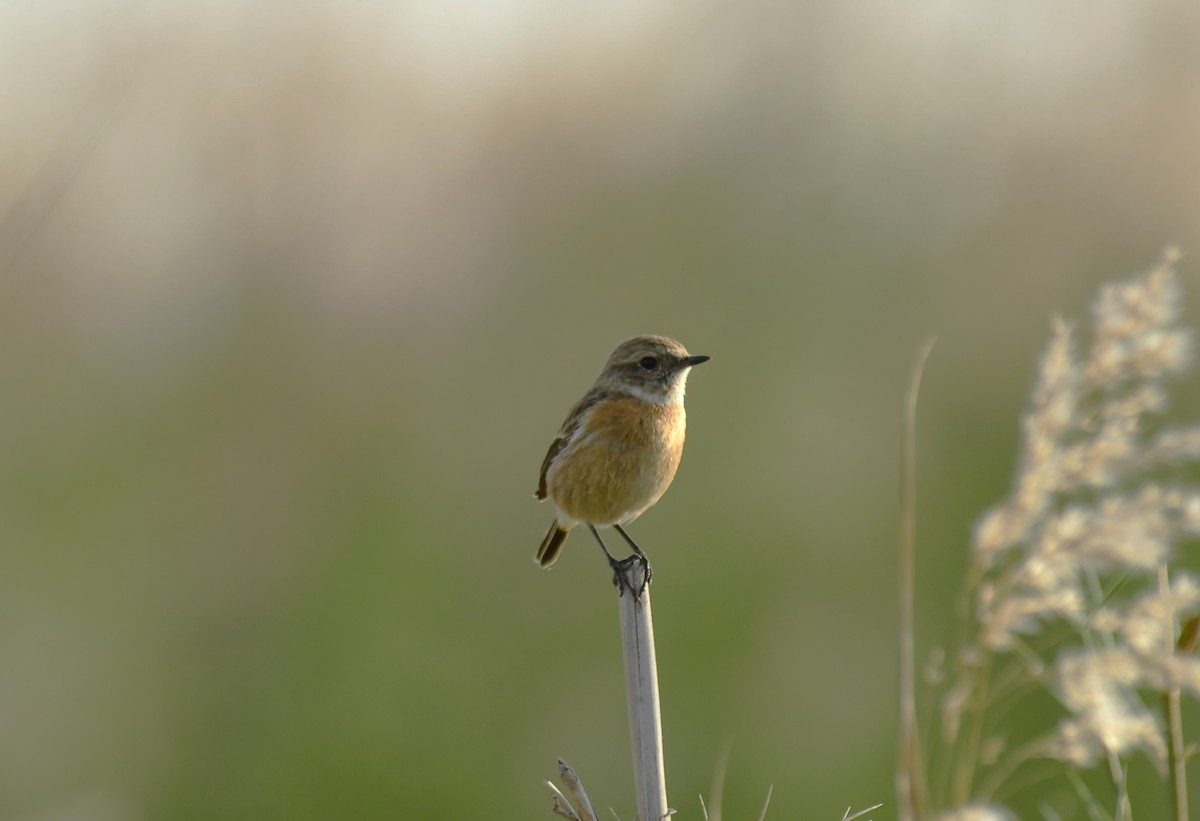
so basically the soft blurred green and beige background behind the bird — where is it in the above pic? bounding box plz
[7,0,1200,821]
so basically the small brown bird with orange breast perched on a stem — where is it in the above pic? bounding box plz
[534,336,708,593]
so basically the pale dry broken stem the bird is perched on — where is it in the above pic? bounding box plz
[617,563,668,821]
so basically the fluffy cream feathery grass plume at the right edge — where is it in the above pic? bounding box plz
[936,250,1200,819]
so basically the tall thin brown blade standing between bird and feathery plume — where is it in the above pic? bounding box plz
[895,340,934,821]
